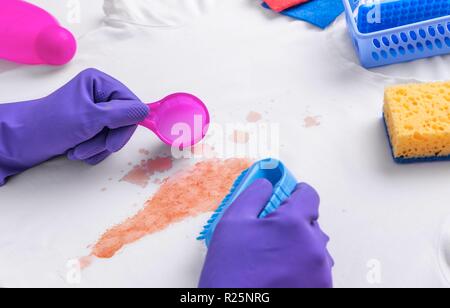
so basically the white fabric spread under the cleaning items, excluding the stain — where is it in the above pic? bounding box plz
[0,0,450,287]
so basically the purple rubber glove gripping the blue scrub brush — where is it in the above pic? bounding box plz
[199,180,334,288]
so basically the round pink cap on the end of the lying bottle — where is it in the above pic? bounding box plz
[36,25,77,65]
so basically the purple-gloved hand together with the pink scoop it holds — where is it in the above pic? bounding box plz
[0,69,209,186]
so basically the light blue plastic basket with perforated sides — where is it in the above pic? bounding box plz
[343,0,450,68]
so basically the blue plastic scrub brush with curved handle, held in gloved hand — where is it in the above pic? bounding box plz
[197,158,298,247]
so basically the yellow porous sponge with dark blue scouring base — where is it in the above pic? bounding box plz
[384,82,450,163]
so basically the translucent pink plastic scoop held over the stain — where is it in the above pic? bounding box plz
[140,93,210,148]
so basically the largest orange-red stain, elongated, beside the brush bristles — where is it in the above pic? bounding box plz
[92,159,251,258]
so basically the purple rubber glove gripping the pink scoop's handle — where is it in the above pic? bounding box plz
[0,69,149,185]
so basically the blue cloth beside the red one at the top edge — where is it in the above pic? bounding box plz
[263,0,344,29]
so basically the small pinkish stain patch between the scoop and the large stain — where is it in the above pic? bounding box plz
[122,157,173,187]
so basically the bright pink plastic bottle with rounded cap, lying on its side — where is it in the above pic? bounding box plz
[0,0,77,65]
